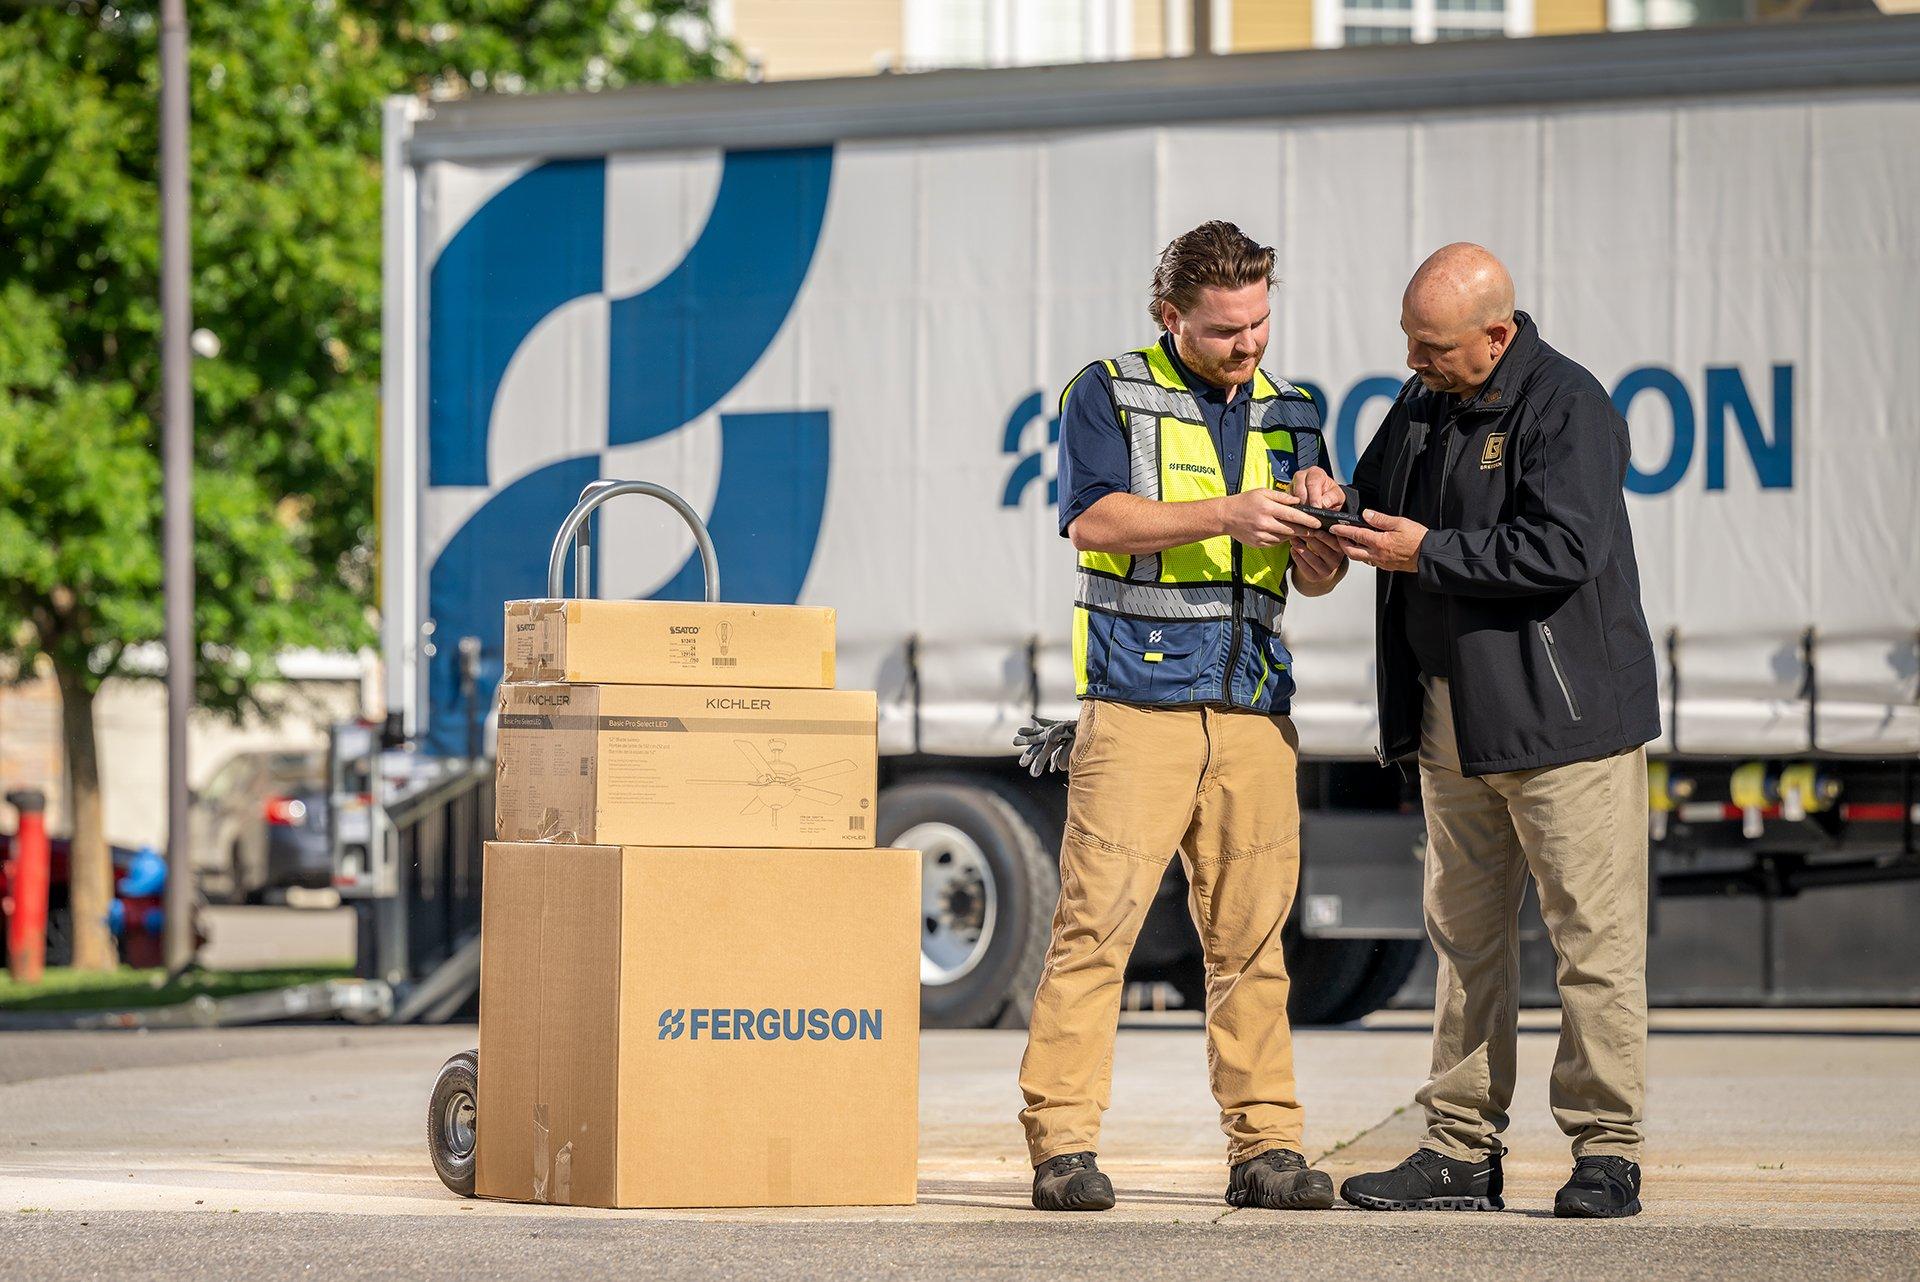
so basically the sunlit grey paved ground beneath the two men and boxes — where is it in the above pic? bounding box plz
[0,1011,1920,1278]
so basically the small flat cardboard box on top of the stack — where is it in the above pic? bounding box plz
[505,601,833,689]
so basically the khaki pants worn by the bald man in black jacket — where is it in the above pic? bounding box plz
[1415,681,1647,1161]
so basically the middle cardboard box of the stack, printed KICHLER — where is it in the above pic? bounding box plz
[493,681,879,850]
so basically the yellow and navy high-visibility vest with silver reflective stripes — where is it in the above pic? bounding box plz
[1062,344,1319,708]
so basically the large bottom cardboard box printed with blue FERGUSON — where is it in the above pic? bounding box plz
[476,843,920,1207]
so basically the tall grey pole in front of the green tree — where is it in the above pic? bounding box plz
[159,0,196,973]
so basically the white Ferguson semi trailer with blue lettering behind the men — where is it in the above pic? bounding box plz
[382,17,1920,1025]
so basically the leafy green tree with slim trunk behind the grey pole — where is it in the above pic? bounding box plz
[0,0,720,967]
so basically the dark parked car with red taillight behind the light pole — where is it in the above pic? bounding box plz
[190,748,332,904]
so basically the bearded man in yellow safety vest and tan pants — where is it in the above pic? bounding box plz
[1020,223,1346,1211]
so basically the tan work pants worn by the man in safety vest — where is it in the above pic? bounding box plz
[1020,700,1302,1165]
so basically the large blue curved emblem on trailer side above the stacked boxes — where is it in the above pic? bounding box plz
[422,148,833,756]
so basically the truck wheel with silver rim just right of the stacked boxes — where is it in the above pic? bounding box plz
[877,773,1060,1029]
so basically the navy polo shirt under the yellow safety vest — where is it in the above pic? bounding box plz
[1058,334,1306,537]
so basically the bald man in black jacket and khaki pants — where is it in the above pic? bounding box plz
[1306,244,1661,1217]
